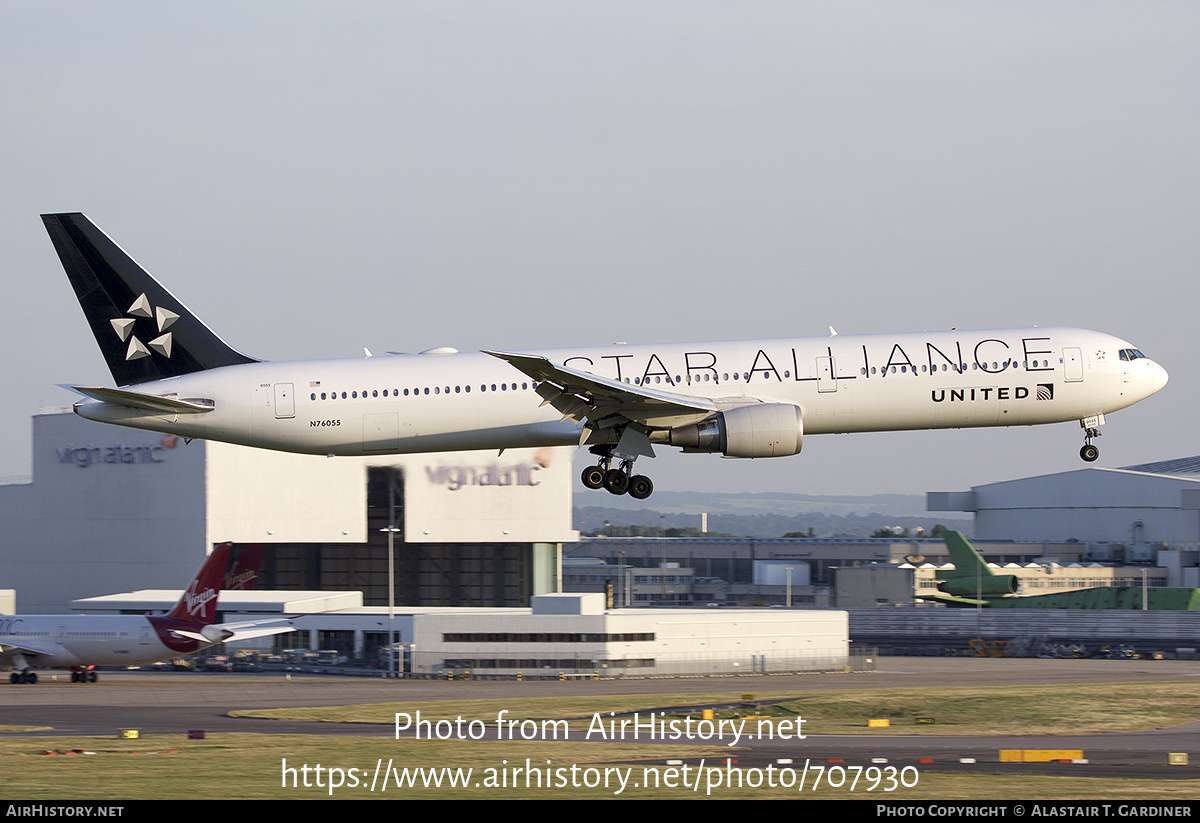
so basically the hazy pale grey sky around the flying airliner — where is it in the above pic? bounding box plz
[0,0,1200,505]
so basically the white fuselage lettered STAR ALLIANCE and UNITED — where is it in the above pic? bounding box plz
[76,328,1166,455]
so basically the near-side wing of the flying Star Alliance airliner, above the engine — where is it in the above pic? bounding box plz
[484,350,718,427]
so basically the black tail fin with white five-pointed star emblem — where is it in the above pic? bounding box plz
[42,214,257,386]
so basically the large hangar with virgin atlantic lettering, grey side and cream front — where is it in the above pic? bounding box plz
[0,409,577,614]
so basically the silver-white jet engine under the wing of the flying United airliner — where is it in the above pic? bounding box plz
[671,403,804,457]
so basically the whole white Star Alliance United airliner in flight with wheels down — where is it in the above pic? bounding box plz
[42,214,1166,499]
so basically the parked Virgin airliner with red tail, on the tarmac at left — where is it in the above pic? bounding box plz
[0,543,292,683]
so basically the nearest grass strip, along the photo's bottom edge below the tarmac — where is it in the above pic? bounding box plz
[0,734,1200,803]
